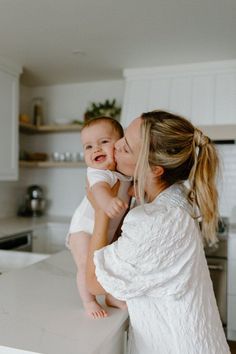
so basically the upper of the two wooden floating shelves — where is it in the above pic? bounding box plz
[19,123,82,134]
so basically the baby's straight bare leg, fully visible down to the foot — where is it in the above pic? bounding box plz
[69,231,107,318]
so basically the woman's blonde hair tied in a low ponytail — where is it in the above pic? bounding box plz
[135,111,219,243]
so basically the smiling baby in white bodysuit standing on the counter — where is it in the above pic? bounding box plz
[67,117,131,318]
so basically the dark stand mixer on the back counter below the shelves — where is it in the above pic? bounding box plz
[18,185,46,216]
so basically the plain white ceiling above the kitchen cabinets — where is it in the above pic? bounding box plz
[0,0,236,86]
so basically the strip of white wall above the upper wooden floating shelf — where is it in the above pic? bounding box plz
[21,80,124,123]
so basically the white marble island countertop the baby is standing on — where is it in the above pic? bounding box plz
[0,250,128,354]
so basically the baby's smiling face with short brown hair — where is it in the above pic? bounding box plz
[81,121,120,170]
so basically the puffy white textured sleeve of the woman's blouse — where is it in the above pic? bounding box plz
[94,206,199,300]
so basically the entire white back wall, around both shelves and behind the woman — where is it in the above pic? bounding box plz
[0,80,236,217]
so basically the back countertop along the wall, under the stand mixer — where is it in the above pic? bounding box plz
[0,216,70,238]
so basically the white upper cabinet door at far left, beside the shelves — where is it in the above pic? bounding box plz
[0,71,19,181]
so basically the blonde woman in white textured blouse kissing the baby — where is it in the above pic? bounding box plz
[87,111,230,354]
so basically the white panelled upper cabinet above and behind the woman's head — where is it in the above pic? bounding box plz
[121,60,236,134]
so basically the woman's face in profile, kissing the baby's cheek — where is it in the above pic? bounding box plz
[115,118,142,176]
